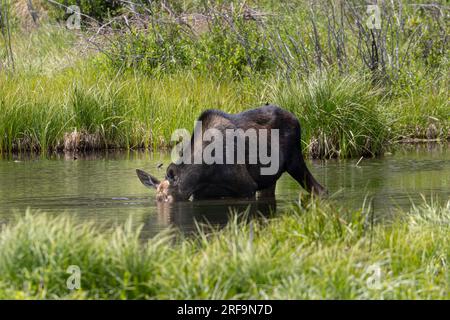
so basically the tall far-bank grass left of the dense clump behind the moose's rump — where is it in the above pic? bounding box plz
[0,64,266,151]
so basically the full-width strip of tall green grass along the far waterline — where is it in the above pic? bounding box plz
[0,59,450,157]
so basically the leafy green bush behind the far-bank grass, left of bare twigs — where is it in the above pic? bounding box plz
[108,5,273,78]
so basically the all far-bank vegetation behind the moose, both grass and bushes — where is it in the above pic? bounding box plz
[0,1,450,157]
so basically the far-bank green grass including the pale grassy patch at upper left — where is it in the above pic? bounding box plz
[0,7,450,158]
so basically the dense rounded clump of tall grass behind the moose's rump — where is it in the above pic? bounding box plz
[274,75,389,158]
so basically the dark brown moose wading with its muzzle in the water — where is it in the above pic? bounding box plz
[137,105,326,201]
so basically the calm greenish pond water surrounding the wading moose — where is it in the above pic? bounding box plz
[0,145,450,236]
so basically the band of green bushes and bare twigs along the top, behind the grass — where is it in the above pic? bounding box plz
[99,1,448,83]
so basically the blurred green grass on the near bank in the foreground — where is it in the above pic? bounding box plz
[0,202,450,299]
